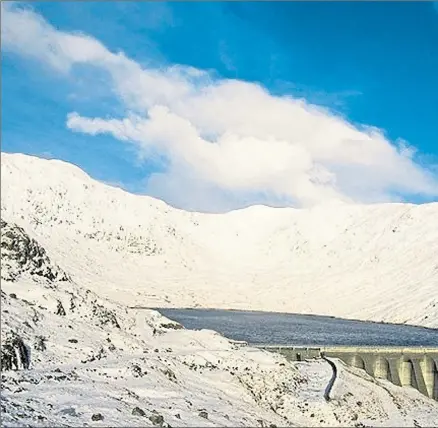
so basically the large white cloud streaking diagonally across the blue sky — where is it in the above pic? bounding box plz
[2,4,438,210]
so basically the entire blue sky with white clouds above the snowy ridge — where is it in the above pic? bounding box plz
[1,1,438,212]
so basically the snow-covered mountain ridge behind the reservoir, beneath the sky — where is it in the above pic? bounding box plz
[1,153,438,327]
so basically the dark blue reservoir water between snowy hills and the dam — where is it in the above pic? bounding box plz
[157,309,438,347]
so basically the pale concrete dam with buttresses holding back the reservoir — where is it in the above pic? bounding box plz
[256,345,438,400]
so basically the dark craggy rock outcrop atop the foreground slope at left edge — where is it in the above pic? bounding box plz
[1,219,69,281]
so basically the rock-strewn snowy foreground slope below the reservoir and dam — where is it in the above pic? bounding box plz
[1,222,438,428]
